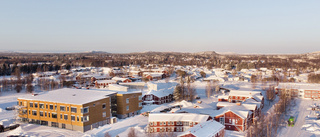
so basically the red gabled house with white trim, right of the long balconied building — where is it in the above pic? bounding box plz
[211,107,253,131]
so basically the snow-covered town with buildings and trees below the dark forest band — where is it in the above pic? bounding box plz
[0,64,320,137]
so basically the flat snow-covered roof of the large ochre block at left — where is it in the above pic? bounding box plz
[19,88,115,105]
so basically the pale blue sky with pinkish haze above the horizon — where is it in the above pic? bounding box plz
[0,0,320,53]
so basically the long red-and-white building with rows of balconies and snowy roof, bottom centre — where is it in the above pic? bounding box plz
[148,113,212,132]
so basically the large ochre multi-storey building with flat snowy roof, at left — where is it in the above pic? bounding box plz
[18,88,113,132]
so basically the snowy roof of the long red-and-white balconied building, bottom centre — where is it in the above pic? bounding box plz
[148,113,209,123]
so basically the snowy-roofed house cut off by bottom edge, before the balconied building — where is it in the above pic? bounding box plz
[178,120,225,137]
